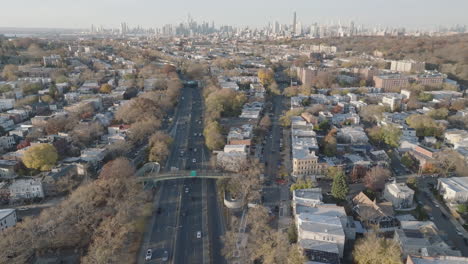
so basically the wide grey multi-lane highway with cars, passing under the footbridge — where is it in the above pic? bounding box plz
[139,84,224,264]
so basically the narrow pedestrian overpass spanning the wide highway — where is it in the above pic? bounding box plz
[137,170,236,186]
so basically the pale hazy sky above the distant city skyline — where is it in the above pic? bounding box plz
[0,0,468,28]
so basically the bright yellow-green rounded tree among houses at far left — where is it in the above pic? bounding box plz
[23,144,58,171]
